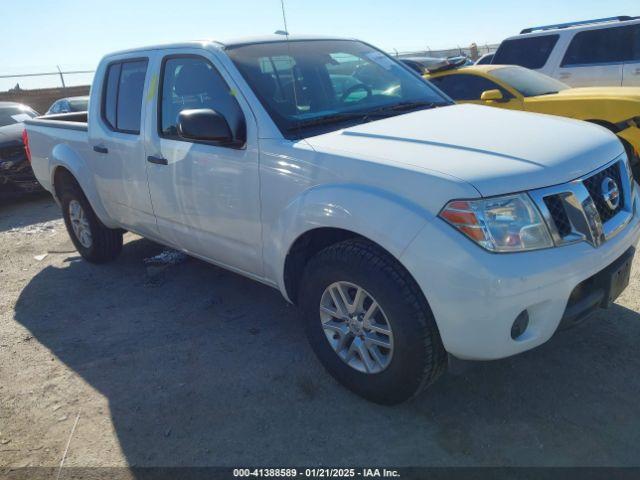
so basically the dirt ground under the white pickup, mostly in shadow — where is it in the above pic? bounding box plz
[0,193,640,470]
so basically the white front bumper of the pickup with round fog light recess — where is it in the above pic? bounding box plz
[400,189,640,360]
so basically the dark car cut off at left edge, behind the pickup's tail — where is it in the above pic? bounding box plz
[0,102,42,198]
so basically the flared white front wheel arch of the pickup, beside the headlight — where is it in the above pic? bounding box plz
[264,184,433,300]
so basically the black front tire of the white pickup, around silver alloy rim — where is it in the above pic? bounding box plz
[299,239,447,405]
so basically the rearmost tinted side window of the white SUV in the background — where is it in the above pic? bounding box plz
[491,35,559,69]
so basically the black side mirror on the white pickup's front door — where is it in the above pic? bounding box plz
[178,108,233,145]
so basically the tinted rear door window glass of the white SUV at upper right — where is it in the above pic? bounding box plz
[561,25,636,67]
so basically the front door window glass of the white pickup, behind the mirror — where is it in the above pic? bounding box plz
[159,56,245,140]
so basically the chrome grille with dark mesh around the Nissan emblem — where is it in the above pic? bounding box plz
[529,155,633,247]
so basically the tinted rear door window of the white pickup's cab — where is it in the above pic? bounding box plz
[102,59,148,134]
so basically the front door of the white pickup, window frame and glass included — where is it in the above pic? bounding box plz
[147,49,262,276]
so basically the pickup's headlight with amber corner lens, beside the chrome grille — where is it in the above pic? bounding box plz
[439,193,553,252]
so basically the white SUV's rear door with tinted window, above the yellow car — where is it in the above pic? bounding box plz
[556,26,633,87]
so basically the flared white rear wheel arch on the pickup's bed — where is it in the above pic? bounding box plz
[50,143,119,228]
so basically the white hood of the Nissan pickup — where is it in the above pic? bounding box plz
[306,105,624,196]
